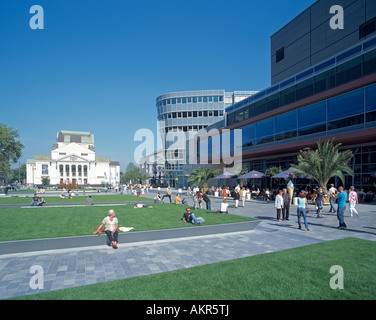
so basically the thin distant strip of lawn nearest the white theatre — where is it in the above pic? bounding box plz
[0,194,153,205]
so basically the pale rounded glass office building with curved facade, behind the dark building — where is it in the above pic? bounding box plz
[145,90,257,188]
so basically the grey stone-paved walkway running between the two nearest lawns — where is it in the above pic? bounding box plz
[0,193,376,299]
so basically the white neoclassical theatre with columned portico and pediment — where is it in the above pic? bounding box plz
[26,130,120,187]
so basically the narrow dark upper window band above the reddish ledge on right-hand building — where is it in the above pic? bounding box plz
[227,50,376,126]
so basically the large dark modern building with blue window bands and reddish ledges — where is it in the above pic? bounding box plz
[197,0,376,189]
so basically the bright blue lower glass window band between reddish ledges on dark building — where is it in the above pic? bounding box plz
[203,84,376,151]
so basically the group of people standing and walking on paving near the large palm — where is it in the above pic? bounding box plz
[274,184,359,231]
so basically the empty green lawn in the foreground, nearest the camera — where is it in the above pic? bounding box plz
[15,238,376,300]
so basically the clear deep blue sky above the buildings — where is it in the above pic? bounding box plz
[0,0,315,170]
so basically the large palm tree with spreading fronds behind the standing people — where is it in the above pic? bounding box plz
[292,140,354,190]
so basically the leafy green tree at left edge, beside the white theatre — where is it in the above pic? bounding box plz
[0,123,24,184]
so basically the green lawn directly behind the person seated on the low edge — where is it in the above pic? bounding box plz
[0,204,253,241]
